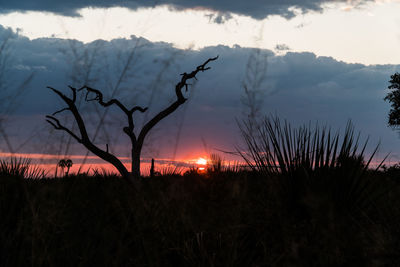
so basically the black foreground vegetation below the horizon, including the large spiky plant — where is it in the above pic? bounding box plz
[0,120,400,267]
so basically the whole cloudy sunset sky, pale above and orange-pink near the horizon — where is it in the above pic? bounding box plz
[0,0,400,174]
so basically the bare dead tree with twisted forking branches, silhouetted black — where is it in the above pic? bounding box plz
[46,56,218,180]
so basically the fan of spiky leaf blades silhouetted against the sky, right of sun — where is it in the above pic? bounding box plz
[237,117,382,176]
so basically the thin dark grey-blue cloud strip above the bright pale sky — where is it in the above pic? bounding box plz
[0,0,372,19]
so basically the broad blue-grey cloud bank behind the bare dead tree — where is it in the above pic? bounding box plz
[0,24,400,159]
